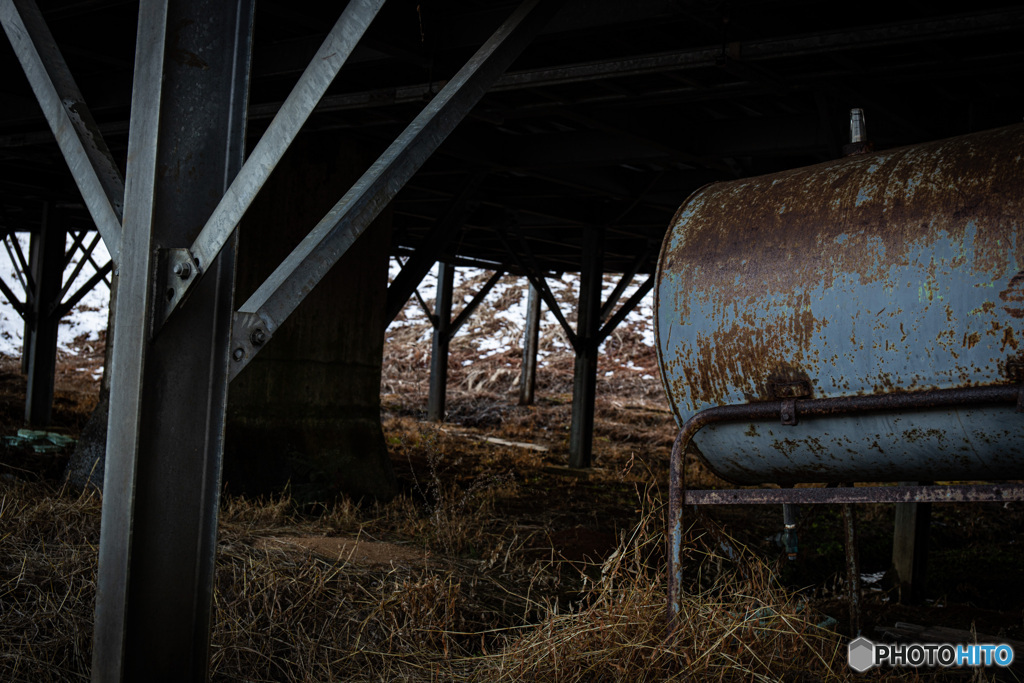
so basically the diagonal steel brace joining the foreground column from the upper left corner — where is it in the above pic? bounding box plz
[0,0,125,262]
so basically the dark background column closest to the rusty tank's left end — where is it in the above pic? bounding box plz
[569,226,604,468]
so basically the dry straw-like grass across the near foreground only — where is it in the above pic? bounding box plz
[0,464,864,681]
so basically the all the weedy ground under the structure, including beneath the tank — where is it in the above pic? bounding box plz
[0,274,1024,682]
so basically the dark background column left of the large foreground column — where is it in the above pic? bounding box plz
[23,204,68,427]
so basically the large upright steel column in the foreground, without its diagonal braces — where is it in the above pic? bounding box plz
[92,0,252,681]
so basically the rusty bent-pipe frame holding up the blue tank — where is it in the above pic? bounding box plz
[668,384,1024,625]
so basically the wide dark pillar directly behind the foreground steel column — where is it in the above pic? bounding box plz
[224,131,397,500]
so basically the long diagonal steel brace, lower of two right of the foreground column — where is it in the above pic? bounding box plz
[231,0,560,377]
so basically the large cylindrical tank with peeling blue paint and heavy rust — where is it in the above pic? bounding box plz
[654,125,1024,484]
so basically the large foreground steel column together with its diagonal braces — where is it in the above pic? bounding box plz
[2,0,558,681]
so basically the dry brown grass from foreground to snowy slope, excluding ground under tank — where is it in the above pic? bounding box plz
[0,274,970,682]
